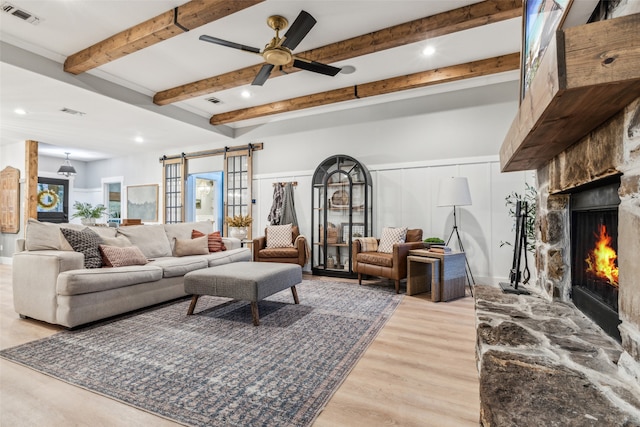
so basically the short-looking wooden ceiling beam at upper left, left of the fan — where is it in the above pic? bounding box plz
[64,0,264,74]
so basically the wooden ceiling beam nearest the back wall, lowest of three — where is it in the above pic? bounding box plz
[209,52,520,125]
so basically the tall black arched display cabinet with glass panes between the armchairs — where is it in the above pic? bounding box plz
[311,155,372,277]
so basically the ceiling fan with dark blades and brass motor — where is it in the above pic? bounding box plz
[200,10,341,86]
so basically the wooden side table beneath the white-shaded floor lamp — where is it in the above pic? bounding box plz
[407,249,467,301]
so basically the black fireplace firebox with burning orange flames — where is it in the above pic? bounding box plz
[570,177,621,341]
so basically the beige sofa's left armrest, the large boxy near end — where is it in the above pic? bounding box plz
[12,250,84,323]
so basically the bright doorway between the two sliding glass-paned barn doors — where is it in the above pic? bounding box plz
[186,171,224,231]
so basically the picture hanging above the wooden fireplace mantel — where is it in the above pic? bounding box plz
[520,0,573,101]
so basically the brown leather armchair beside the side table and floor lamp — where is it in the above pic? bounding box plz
[352,228,424,293]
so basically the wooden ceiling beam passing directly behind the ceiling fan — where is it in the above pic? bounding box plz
[153,0,522,105]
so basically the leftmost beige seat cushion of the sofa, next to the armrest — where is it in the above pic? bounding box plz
[56,265,162,295]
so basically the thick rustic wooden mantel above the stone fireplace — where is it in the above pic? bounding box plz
[500,13,640,172]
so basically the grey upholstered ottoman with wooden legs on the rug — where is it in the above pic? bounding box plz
[184,262,302,326]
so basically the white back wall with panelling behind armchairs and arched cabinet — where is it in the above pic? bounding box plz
[0,81,531,282]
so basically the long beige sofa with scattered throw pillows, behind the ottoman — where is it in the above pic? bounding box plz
[13,220,251,327]
